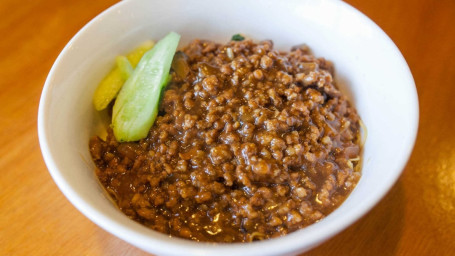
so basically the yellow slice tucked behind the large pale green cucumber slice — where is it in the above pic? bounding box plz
[93,40,155,111]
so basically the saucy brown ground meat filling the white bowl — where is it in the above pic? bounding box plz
[90,37,360,242]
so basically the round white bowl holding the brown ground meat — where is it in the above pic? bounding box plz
[38,0,418,256]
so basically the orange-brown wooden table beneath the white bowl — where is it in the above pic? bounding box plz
[0,0,455,255]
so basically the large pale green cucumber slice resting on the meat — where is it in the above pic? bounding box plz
[112,32,180,142]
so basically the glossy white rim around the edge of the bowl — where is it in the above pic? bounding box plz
[38,0,419,256]
